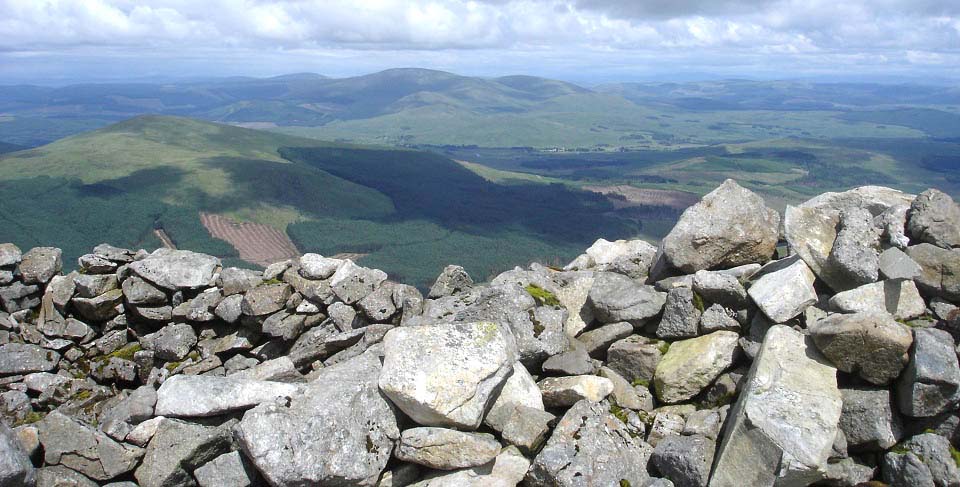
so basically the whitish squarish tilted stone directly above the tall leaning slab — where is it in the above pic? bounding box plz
[748,258,817,323]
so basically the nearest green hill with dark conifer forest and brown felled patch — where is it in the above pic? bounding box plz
[0,116,640,286]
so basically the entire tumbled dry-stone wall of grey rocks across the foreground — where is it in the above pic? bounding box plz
[0,181,960,487]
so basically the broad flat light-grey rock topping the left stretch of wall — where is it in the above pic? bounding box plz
[130,248,220,291]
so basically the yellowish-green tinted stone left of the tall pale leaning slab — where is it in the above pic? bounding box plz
[653,331,740,404]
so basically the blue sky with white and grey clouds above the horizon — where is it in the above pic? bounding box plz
[0,0,960,85]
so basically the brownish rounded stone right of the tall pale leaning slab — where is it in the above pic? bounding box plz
[808,312,913,385]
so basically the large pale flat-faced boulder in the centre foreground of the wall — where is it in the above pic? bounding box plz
[380,322,517,430]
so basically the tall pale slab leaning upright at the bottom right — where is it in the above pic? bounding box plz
[710,325,842,487]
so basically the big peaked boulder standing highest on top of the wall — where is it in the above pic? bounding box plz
[661,179,780,274]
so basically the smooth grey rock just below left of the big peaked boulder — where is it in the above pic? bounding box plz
[587,272,667,327]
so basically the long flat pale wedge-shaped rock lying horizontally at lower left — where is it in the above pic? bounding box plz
[156,375,301,417]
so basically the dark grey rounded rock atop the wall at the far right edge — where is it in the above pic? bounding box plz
[907,189,960,249]
